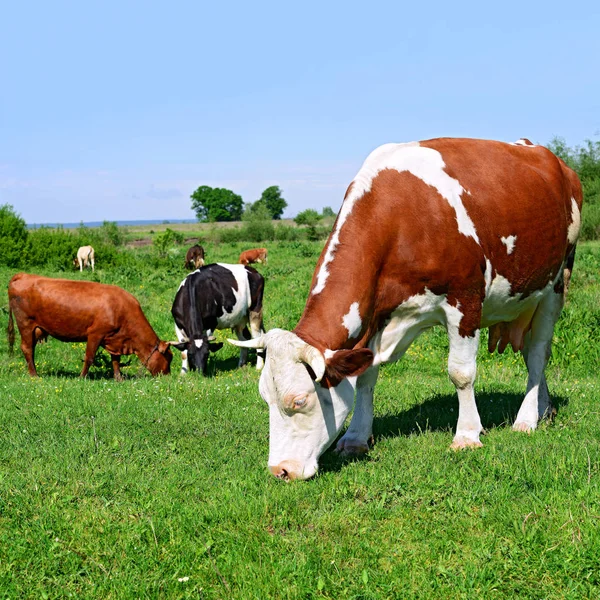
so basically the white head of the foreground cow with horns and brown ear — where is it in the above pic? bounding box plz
[229,329,373,480]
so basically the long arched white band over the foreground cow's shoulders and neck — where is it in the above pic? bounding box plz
[312,142,479,294]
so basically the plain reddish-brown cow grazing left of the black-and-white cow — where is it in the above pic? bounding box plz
[8,273,173,381]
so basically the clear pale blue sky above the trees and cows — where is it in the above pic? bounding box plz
[0,0,600,223]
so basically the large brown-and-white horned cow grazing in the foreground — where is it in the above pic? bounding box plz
[232,138,582,479]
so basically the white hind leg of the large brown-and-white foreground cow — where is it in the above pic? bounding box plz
[513,291,564,432]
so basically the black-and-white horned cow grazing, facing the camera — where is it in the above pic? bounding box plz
[171,263,265,374]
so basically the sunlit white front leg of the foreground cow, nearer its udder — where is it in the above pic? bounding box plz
[448,323,483,450]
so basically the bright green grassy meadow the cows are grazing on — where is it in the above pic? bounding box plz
[0,242,600,600]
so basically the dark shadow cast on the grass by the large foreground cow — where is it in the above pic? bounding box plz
[319,392,569,472]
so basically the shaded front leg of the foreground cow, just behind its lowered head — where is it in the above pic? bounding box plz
[335,367,379,456]
